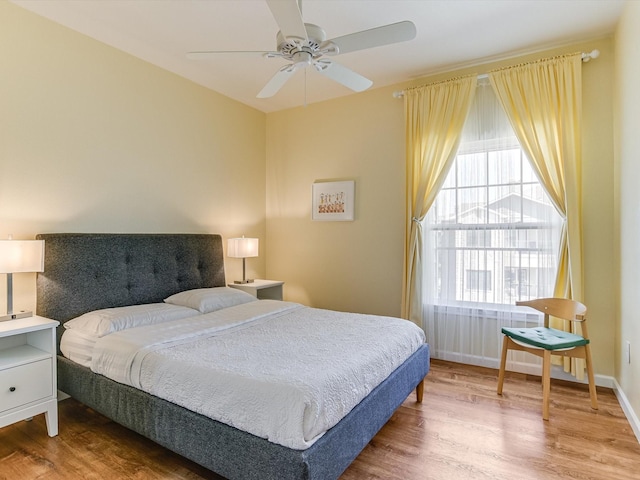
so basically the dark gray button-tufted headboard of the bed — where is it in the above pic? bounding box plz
[36,233,225,341]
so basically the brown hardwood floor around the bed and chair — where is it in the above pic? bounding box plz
[0,360,640,480]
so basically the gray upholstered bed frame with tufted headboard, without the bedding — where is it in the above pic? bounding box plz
[32,234,429,480]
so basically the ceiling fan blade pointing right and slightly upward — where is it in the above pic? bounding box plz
[322,21,416,54]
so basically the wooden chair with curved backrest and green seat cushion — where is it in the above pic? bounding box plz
[498,298,598,420]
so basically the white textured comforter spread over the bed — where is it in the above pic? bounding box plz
[91,300,424,450]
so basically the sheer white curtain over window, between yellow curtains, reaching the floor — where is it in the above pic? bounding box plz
[422,82,562,373]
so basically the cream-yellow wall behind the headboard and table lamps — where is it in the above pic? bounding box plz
[0,1,266,311]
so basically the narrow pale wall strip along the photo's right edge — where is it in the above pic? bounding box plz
[615,2,640,424]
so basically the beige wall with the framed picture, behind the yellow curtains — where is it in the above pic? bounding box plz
[267,38,615,375]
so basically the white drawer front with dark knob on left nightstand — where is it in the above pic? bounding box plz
[0,358,53,412]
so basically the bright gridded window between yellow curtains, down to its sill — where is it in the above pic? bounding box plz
[424,84,561,305]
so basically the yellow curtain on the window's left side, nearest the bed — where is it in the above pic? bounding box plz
[402,75,477,326]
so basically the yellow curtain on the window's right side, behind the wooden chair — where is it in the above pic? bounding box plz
[489,53,584,378]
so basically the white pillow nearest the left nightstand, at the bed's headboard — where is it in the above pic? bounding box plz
[64,303,199,337]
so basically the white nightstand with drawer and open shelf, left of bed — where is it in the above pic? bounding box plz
[0,316,59,437]
